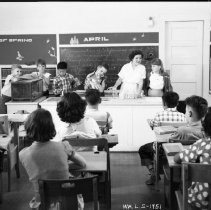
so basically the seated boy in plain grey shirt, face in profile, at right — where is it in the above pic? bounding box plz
[169,95,208,141]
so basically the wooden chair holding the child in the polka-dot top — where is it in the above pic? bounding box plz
[175,163,211,210]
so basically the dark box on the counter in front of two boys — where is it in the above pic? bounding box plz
[11,79,43,101]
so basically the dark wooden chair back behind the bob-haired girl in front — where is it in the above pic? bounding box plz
[38,176,99,210]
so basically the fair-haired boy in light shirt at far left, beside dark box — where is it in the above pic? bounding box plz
[1,64,22,114]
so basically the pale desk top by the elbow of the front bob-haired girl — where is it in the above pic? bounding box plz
[73,151,107,172]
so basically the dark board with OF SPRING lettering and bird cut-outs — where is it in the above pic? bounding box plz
[0,34,57,65]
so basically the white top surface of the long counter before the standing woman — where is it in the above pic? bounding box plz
[40,97,162,106]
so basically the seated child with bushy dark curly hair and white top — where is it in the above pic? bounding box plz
[56,92,102,141]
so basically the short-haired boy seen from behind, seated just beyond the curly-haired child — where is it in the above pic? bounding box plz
[85,89,113,134]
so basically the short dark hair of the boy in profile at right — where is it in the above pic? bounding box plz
[185,95,208,120]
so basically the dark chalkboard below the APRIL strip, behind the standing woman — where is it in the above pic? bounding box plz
[60,46,159,89]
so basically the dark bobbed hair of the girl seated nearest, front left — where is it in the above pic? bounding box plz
[24,109,56,142]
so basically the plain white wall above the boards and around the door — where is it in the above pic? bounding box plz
[0,2,211,104]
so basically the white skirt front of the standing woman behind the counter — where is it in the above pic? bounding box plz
[119,82,138,99]
